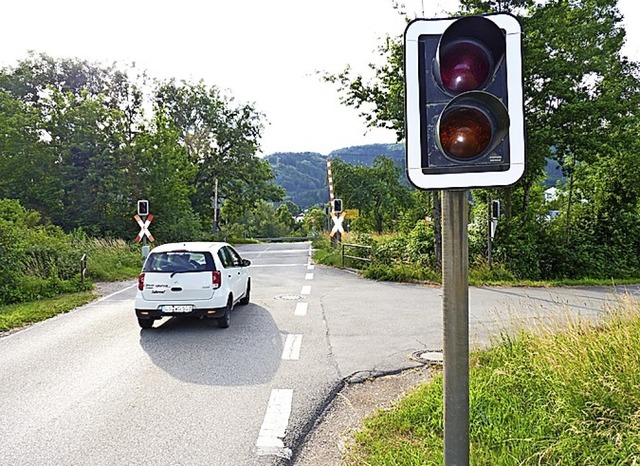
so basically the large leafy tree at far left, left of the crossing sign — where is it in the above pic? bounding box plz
[0,53,151,236]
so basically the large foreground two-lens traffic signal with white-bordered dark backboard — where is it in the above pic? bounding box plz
[405,14,525,189]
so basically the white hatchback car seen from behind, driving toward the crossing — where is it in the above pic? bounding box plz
[135,242,251,328]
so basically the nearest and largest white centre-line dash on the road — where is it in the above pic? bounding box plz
[256,388,293,459]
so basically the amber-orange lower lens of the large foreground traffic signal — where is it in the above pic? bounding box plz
[439,107,493,160]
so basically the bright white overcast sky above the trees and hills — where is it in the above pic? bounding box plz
[0,0,640,155]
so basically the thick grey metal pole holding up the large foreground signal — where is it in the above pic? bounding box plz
[442,190,469,466]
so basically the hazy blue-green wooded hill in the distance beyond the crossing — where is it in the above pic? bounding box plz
[265,144,405,209]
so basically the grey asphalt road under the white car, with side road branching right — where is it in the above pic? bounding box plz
[0,243,638,466]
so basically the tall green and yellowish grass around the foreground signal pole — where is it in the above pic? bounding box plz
[345,301,640,466]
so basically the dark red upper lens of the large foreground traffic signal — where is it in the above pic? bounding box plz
[440,41,493,94]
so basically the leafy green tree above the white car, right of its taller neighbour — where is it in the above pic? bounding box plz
[155,80,284,228]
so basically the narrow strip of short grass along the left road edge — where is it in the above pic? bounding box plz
[0,291,96,332]
